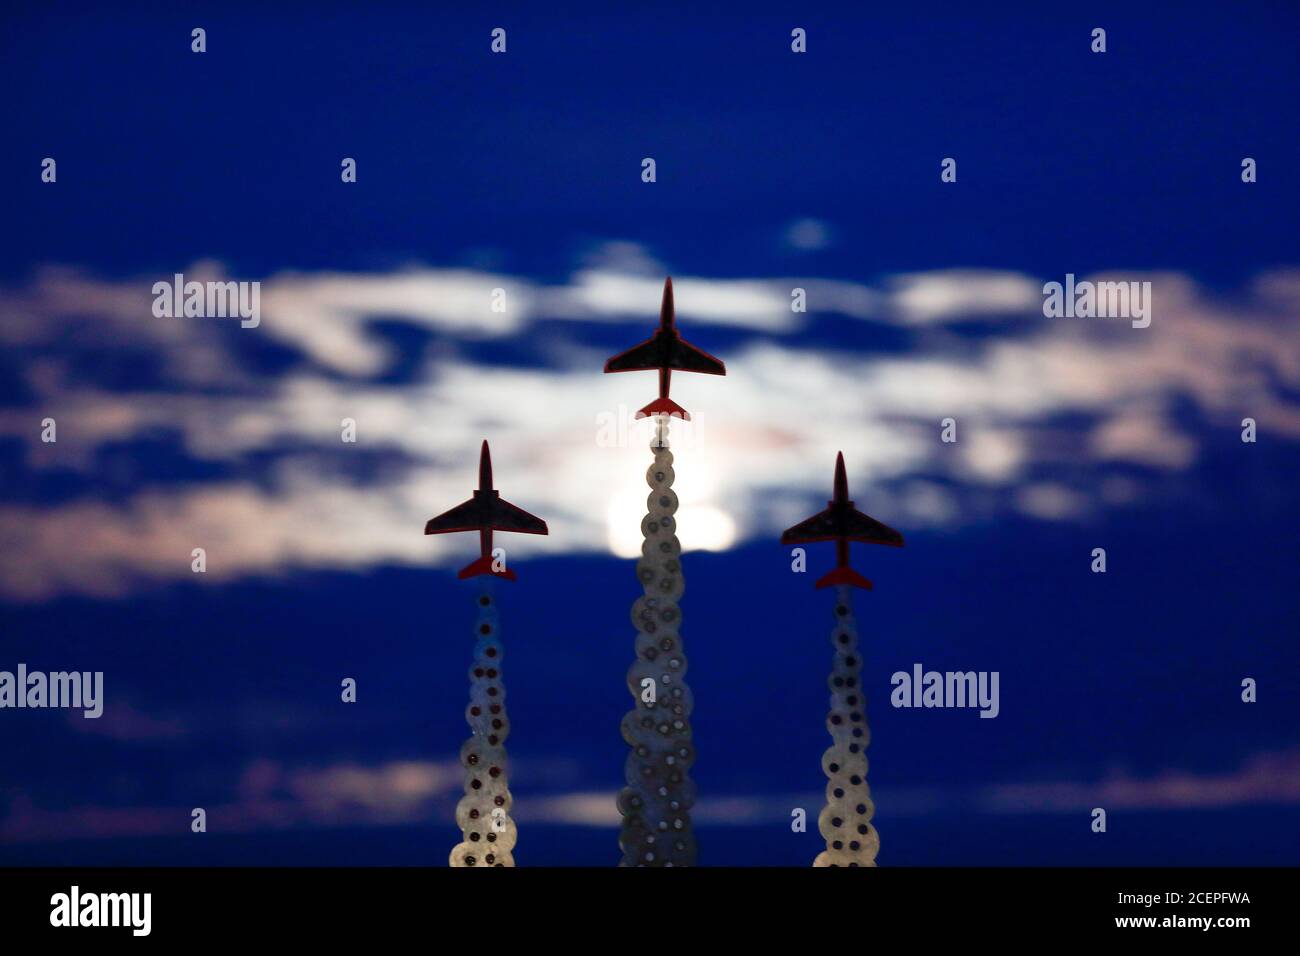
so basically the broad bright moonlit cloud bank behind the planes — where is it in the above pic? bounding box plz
[0,254,1300,600]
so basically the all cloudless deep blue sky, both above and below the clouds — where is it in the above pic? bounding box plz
[0,3,1300,865]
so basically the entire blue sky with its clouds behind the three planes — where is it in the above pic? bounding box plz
[0,3,1300,866]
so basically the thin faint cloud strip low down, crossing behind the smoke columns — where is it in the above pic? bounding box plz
[0,748,1300,843]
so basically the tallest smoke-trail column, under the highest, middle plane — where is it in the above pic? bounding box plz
[619,415,696,866]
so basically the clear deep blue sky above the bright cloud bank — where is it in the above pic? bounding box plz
[4,3,1300,280]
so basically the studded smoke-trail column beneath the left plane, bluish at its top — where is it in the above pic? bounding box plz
[451,578,516,866]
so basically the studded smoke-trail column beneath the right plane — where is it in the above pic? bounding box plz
[813,584,880,866]
